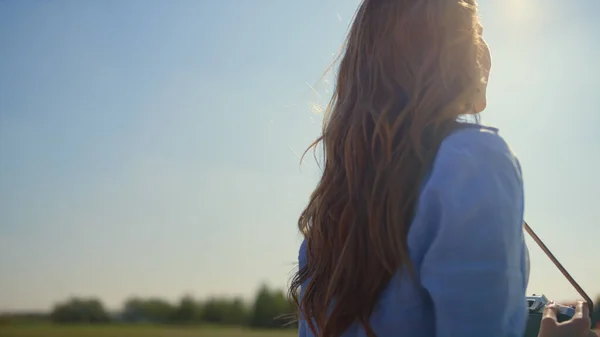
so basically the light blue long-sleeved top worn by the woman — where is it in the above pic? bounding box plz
[299,127,528,337]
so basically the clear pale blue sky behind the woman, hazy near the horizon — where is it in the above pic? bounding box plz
[0,0,600,310]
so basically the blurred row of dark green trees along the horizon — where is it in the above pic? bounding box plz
[49,286,297,328]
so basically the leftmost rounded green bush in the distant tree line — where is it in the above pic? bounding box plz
[50,298,110,323]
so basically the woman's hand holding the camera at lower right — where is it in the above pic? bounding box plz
[538,302,598,337]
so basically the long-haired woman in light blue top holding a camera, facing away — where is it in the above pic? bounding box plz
[290,0,589,337]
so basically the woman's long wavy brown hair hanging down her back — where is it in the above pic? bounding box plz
[289,0,489,337]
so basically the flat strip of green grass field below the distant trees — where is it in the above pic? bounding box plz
[0,324,297,337]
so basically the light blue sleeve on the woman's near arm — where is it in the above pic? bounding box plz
[419,132,526,337]
